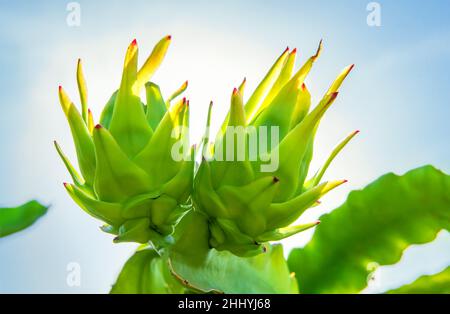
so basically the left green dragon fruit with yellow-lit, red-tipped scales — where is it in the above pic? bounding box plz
[55,36,194,243]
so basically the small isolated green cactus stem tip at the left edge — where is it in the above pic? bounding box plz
[0,201,48,238]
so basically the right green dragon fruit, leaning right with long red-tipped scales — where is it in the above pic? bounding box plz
[193,43,357,256]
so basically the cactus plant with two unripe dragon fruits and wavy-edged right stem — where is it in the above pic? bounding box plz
[55,36,450,293]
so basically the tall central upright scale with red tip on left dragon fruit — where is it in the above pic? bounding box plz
[109,40,152,157]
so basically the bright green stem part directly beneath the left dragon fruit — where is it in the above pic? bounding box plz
[110,248,184,294]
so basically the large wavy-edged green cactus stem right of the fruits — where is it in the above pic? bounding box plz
[288,166,450,293]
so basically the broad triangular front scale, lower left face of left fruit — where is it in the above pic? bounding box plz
[94,125,152,202]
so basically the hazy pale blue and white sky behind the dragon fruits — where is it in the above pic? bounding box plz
[0,0,450,293]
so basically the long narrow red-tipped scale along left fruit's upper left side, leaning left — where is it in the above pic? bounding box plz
[59,86,95,185]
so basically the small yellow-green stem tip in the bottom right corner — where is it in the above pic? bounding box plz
[387,267,450,294]
